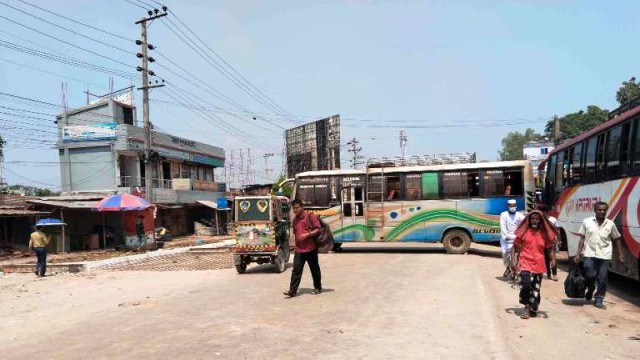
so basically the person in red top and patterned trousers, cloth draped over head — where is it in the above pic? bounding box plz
[511,210,556,319]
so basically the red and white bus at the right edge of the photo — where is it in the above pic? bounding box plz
[544,102,640,279]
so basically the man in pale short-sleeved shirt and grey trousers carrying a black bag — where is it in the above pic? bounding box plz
[573,201,625,309]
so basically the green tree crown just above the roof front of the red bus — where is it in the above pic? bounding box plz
[544,105,609,139]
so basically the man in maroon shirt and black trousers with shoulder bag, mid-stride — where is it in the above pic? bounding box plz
[284,199,322,297]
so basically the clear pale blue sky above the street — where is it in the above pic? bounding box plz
[0,0,640,189]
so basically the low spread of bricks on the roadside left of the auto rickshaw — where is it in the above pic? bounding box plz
[105,249,233,271]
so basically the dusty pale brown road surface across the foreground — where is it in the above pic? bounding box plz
[0,242,640,359]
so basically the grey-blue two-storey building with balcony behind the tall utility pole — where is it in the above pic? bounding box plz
[52,98,226,234]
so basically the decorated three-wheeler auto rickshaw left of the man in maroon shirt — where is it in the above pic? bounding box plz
[233,195,293,274]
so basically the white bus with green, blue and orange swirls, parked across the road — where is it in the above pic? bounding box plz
[293,160,535,254]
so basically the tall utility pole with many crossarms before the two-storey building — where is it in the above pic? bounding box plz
[136,6,167,202]
